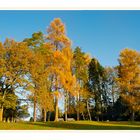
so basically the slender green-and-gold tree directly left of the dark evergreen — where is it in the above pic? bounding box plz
[73,47,90,120]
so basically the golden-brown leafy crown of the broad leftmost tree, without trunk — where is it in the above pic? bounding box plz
[0,39,31,86]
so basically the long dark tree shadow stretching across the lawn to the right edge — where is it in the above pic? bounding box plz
[26,122,140,130]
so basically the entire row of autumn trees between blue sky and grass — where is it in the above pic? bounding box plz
[0,18,140,122]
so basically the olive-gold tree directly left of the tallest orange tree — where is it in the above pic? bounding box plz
[29,44,51,121]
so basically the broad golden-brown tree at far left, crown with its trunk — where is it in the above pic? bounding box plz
[0,39,31,121]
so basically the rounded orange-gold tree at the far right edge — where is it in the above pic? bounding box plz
[118,48,140,121]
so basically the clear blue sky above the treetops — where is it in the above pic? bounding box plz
[0,11,140,66]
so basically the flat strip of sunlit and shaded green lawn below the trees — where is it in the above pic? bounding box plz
[0,121,140,130]
